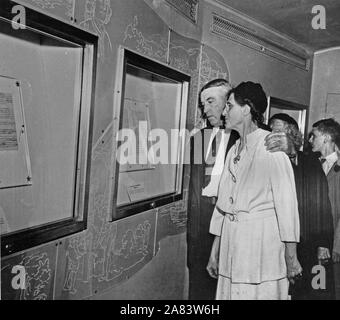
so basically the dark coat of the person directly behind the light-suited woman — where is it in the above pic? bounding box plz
[290,152,334,300]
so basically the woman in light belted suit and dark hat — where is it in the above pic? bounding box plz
[207,82,302,300]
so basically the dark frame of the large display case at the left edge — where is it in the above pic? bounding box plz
[0,0,98,256]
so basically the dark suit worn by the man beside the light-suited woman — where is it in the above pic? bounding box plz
[187,128,238,300]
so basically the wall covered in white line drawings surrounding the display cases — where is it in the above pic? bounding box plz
[2,0,311,300]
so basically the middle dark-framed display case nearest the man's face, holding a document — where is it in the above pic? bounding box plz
[110,48,190,220]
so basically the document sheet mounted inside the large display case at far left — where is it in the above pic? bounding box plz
[0,76,32,189]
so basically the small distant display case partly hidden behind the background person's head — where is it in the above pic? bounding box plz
[265,96,308,148]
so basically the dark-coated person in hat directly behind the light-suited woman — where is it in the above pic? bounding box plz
[269,113,334,300]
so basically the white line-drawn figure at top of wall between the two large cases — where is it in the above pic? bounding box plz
[79,0,112,61]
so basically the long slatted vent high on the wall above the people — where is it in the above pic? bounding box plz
[211,14,310,70]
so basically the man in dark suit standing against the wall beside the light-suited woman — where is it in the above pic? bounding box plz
[187,79,238,300]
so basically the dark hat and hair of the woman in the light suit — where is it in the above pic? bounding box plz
[228,81,268,126]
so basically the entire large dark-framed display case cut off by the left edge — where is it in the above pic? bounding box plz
[0,3,97,255]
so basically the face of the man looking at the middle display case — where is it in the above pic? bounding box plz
[201,87,228,127]
